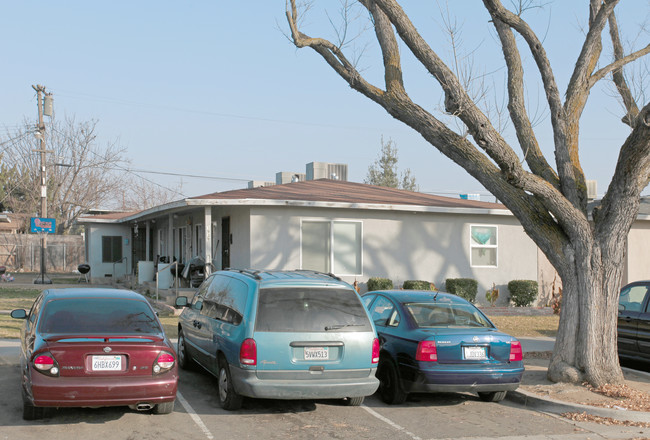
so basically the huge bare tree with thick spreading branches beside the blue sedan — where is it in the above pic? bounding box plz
[286,0,650,386]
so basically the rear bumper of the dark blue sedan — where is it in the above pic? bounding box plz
[402,367,524,393]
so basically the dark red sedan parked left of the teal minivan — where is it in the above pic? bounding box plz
[11,288,178,420]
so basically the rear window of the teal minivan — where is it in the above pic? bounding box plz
[255,287,372,332]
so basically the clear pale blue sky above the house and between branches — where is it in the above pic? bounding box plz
[0,0,650,201]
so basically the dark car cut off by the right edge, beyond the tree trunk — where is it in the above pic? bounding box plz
[617,281,650,362]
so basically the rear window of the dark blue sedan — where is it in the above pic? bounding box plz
[404,302,493,328]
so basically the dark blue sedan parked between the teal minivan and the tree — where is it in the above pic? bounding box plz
[363,290,524,404]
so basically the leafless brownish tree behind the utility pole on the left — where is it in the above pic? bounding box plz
[3,118,125,233]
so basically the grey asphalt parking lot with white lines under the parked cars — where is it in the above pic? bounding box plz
[0,340,650,440]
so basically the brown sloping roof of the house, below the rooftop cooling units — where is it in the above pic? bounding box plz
[190,179,506,209]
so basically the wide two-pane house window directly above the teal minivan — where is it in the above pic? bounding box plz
[301,220,362,275]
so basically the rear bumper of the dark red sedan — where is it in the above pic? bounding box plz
[24,369,178,407]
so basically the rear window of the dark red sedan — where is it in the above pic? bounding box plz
[39,298,162,335]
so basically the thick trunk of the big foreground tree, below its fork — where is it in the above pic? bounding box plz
[548,239,624,386]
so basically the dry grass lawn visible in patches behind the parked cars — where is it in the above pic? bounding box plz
[0,287,559,338]
